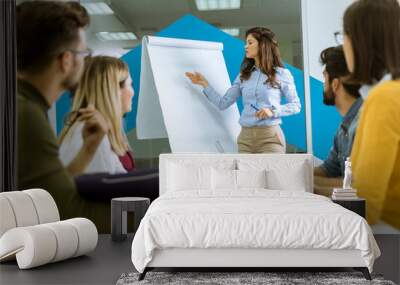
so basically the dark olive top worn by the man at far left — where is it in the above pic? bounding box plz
[17,80,110,233]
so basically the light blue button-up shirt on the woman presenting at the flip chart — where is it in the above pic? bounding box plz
[203,67,301,127]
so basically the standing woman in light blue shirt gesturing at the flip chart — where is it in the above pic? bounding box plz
[186,27,301,153]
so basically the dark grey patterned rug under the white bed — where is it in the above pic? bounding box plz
[117,272,395,285]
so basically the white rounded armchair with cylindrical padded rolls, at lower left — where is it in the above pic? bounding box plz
[0,189,98,269]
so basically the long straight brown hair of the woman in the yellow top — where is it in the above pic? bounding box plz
[343,0,400,84]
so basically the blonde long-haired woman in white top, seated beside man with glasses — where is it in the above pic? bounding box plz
[60,56,135,175]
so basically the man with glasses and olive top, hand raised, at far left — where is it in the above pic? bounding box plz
[16,1,110,232]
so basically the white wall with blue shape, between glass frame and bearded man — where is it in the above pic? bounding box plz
[301,0,352,155]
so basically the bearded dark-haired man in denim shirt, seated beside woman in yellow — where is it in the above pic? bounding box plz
[314,45,363,196]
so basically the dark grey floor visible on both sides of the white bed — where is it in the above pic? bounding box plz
[0,235,400,285]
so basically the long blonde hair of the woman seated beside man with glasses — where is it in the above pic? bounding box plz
[59,56,129,156]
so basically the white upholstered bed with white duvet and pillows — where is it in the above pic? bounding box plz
[132,153,380,279]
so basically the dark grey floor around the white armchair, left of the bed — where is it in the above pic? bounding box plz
[0,235,134,285]
